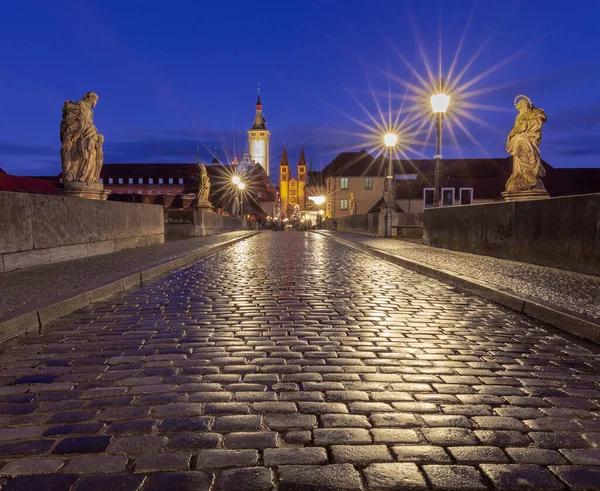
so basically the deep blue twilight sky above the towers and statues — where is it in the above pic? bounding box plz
[0,0,600,178]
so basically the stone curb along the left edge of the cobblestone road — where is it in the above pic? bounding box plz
[0,232,259,348]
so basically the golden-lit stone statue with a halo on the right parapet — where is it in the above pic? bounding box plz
[502,95,549,201]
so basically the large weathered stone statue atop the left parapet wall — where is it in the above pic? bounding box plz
[60,92,104,185]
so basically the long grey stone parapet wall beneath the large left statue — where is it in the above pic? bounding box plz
[0,191,164,273]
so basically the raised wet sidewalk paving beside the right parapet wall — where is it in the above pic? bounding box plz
[322,232,600,319]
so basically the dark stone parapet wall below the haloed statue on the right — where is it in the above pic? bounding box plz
[424,194,600,276]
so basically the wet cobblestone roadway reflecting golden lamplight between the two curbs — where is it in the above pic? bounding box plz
[0,232,600,491]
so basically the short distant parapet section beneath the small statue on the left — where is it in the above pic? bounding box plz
[164,208,245,237]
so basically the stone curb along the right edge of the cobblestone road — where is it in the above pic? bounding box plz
[314,231,600,344]
